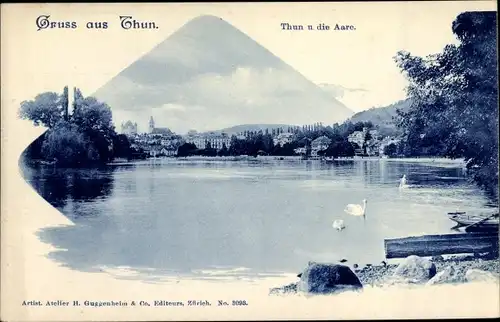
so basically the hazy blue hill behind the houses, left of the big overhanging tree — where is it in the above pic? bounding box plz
[350,100,410,135]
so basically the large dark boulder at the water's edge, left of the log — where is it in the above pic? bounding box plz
[297,262,363,294]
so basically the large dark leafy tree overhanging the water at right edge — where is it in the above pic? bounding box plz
[395,12,498,193]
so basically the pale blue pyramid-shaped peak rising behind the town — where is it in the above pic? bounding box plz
[94,16,352,131]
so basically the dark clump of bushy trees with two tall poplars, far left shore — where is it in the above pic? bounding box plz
[19,86,131,167]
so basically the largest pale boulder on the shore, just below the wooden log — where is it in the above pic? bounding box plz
[393,255,436,283]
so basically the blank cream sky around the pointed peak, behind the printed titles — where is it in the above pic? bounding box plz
[1,1,496,133]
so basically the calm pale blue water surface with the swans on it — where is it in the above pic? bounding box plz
[22,160,492,278]
